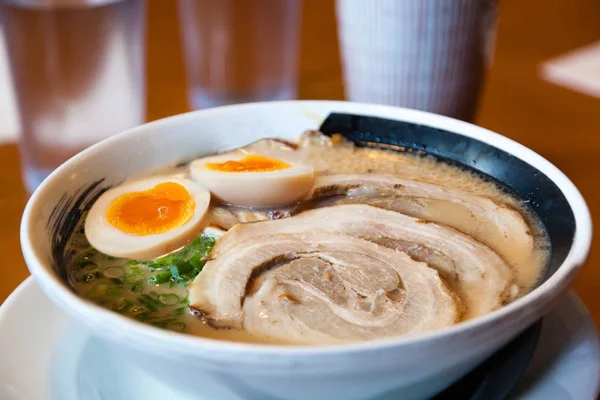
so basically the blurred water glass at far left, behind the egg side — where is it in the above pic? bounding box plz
[0,0,145,192]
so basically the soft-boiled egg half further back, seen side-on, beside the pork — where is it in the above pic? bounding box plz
[190,152,315,207]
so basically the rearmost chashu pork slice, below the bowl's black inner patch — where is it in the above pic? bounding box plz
[308,174,539,287]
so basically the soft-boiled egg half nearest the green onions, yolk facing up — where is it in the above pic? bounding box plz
[85,177,210,259]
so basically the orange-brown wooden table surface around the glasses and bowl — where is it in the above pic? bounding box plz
[0,0,600,332]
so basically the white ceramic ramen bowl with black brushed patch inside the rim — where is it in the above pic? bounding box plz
[21,101,592,400]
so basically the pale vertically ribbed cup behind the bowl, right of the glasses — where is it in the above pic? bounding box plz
[337,0,496,120]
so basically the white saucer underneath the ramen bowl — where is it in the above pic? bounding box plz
[0,278,600,400]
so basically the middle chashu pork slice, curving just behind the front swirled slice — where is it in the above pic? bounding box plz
[210,204,519,319]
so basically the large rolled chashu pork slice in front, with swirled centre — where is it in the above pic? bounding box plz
[189,233,460,344]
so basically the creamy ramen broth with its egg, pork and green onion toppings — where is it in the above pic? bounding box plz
[69,132,549,345]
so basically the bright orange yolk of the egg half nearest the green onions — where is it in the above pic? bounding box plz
[105,182,196,236]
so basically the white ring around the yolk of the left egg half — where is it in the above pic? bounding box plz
[85,176,210,259]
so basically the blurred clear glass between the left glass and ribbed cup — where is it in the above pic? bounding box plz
[179,0,301,108]
